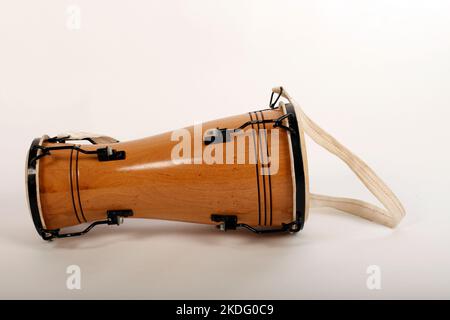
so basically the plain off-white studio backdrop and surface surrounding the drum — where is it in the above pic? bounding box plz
[0,0,450,299]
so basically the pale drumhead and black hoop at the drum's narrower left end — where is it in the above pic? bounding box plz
[25,137,51,240]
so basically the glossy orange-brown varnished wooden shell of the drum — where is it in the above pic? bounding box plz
[39,109,293,229]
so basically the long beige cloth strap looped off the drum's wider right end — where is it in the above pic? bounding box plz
[273,87,405,228]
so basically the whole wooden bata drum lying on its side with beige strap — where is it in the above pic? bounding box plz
[26,87,404,240]
